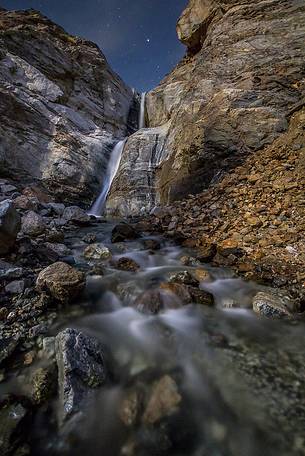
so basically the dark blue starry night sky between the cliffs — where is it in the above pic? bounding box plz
[0,0,188,91]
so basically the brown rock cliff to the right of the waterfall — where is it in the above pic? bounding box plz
[108,0,305,214]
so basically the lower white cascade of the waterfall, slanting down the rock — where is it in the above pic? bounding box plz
[89,138,127,217]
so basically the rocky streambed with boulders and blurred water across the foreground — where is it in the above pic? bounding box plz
[0,181,305,456]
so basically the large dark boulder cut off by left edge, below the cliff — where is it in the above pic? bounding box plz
[0,200,20,255]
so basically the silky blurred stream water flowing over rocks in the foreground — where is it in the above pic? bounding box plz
[2,222,305,456]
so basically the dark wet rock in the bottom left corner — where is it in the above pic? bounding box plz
[0,402,27,456]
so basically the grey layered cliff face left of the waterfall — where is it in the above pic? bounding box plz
[0,10,137,202]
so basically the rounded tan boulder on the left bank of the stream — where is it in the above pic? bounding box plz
[36,262,85,302]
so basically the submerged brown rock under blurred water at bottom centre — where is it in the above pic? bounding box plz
[143,375,182,424]
